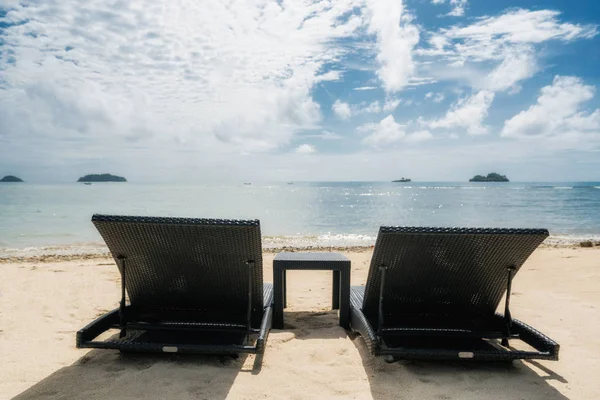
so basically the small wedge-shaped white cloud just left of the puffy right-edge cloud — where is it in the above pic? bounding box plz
[427,90,494,135]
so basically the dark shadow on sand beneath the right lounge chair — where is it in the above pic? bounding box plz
[350,334,567,400]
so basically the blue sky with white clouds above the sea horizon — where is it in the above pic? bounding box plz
[0,0,600,182]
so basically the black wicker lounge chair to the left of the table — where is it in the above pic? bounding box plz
[77,215,273,355]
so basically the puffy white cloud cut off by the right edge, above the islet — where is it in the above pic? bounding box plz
[502,76,600,140]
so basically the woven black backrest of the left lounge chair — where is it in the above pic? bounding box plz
[92,214,263,325]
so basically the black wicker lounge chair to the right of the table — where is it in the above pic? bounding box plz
[350,227,559,360]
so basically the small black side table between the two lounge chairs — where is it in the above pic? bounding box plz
[273,252,350,329]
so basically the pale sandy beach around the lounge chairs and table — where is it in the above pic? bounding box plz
[0,247,600,400]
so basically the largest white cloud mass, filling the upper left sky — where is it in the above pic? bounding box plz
[0,0,362,158]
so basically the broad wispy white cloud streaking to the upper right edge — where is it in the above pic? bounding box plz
[415,9,598,97]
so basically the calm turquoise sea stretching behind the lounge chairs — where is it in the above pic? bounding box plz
[0,182,600,257]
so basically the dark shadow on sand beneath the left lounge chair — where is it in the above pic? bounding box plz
[14,350,262,400]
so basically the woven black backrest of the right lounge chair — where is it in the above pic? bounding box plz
[363,227,548,320]
